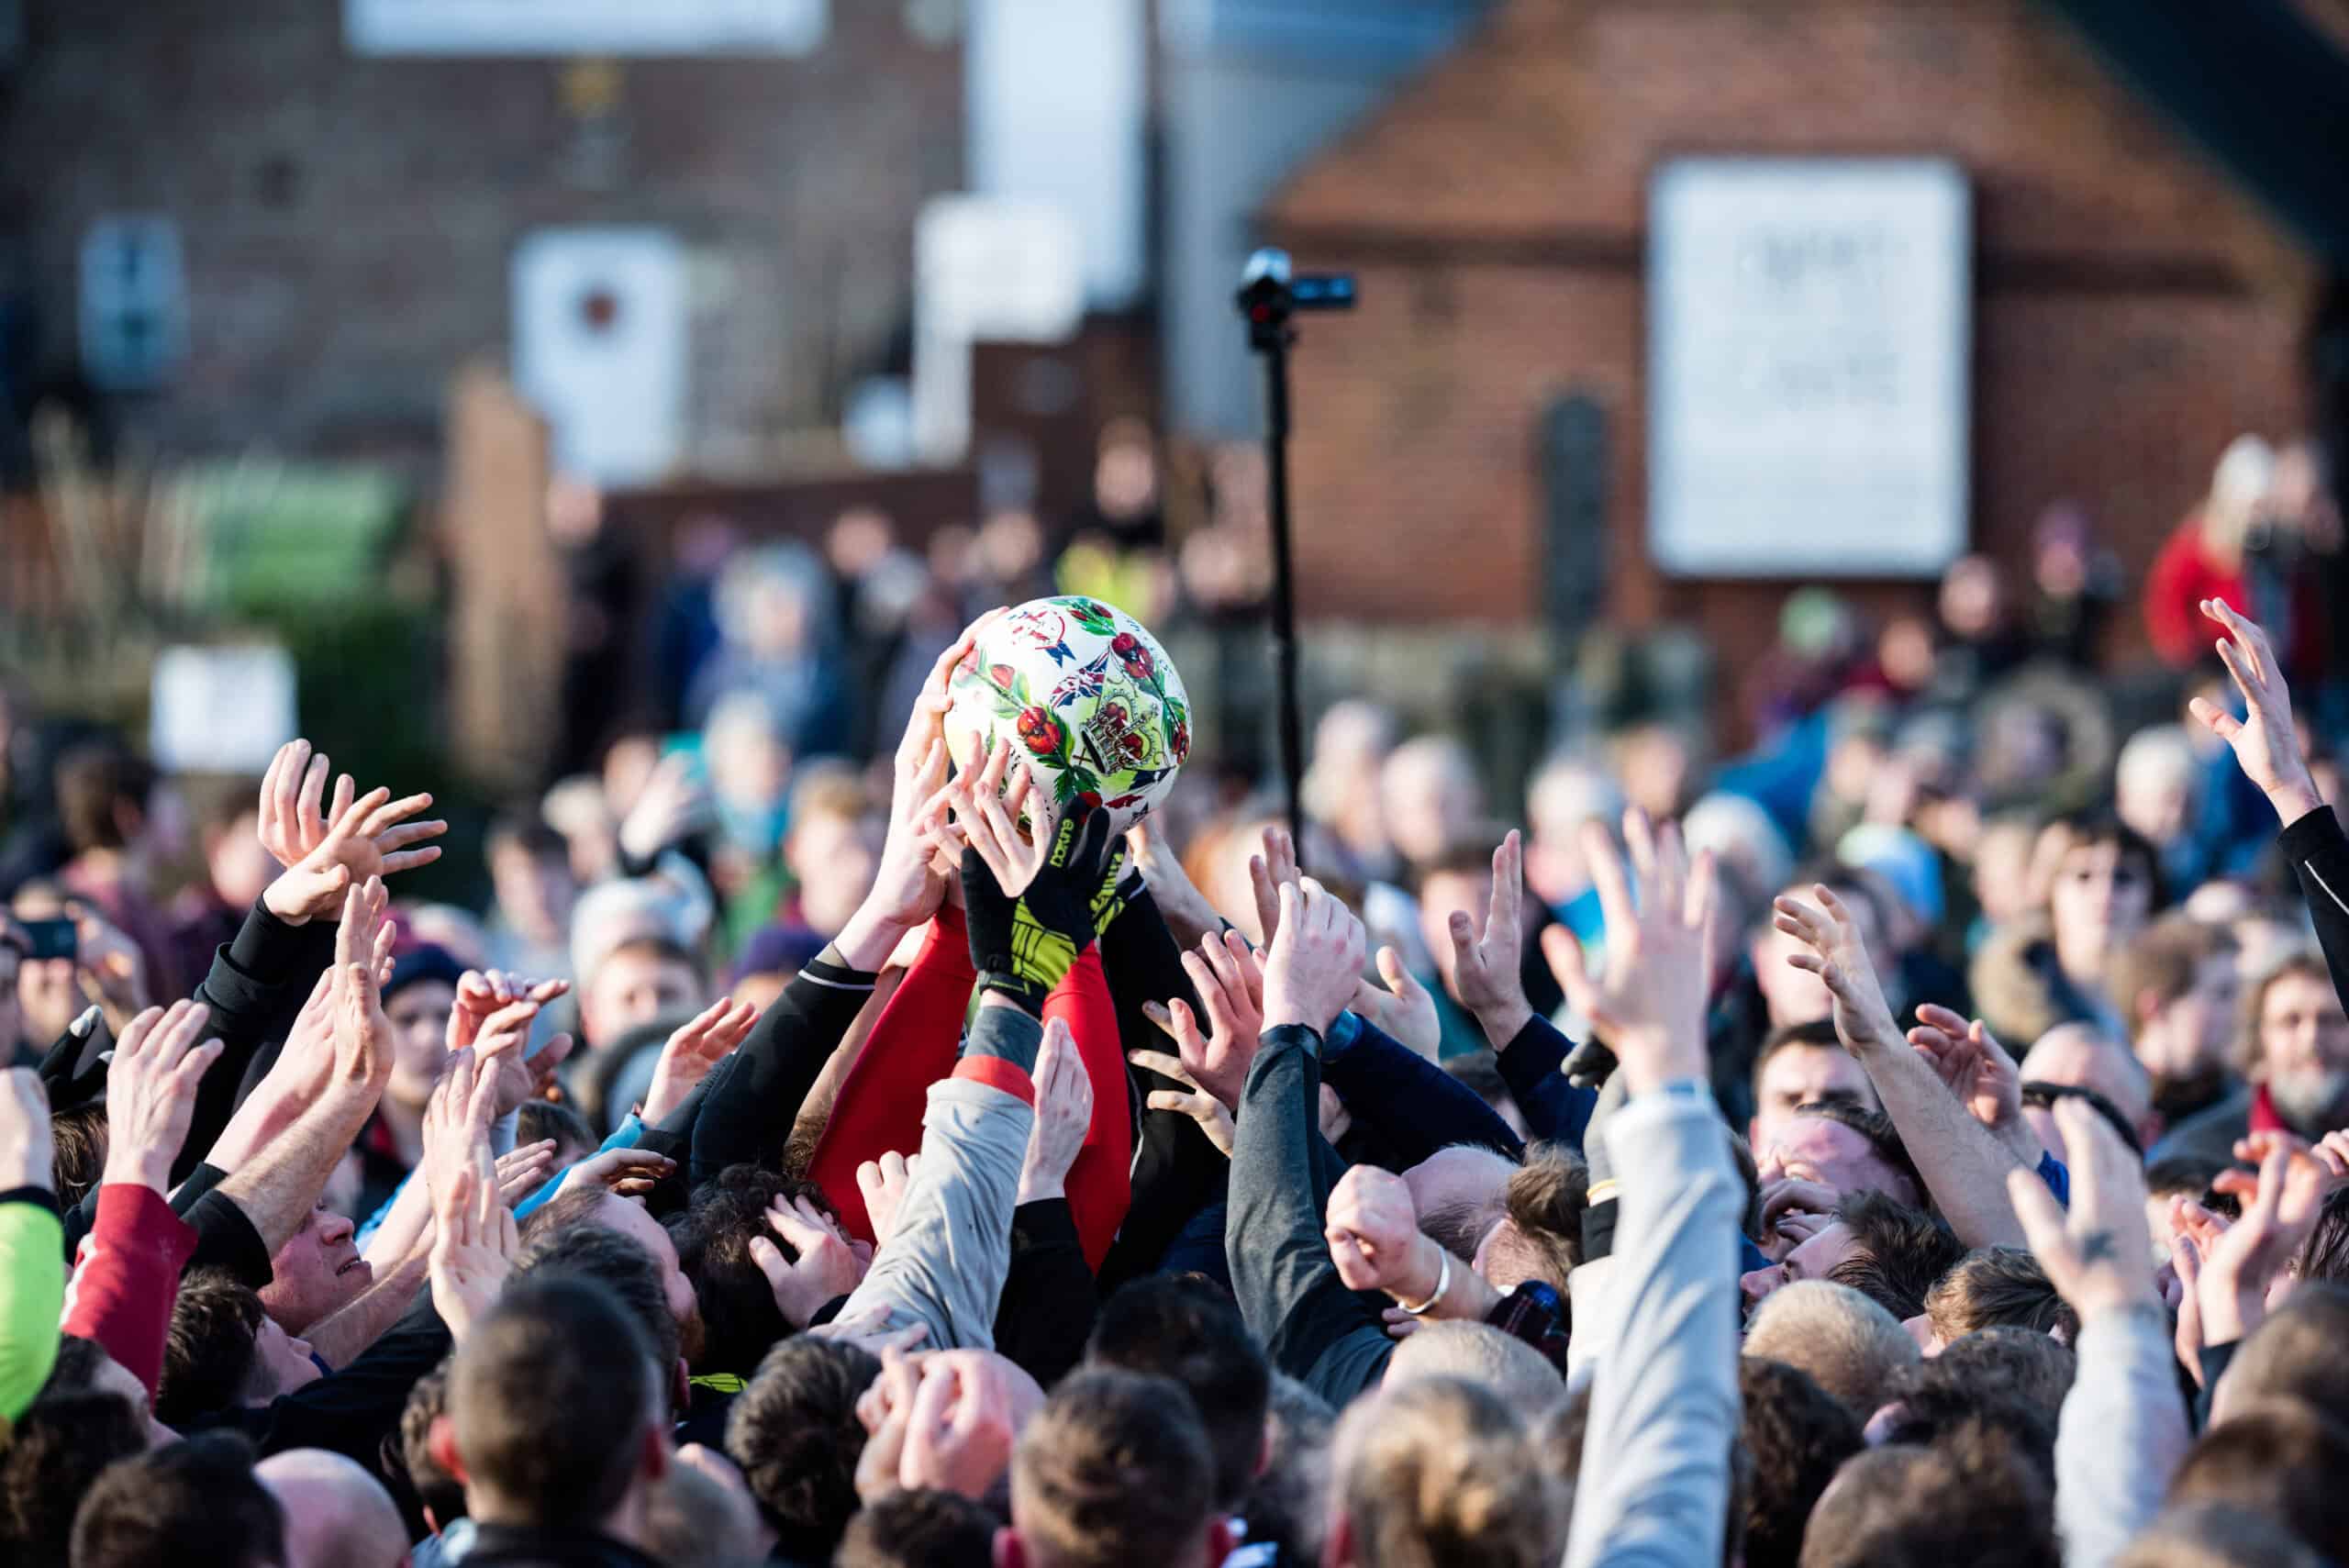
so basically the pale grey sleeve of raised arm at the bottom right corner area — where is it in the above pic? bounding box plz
[2055,1307,2194,1568]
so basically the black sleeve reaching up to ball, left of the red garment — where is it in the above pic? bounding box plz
[693,960,876,1185]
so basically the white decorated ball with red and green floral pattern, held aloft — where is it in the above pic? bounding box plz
[947,596,1191,833]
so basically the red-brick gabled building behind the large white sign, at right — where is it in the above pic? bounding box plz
[1262,0,2314,669]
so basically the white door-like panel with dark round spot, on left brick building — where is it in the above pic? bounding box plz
[515,228,691,484]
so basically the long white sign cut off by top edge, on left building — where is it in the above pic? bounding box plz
[343,0,831,56]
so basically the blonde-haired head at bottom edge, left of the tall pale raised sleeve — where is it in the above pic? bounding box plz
[1332,1371,1564,1568]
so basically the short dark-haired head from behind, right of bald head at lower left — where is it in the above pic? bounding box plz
[449,1277,662,1526]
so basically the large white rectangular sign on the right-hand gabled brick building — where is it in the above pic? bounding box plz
[1647,157,1973,577]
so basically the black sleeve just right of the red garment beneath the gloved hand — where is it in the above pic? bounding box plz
[1102,890,1230,1291]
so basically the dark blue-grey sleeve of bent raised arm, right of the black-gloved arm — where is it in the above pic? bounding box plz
[1224,1026,1396,1408]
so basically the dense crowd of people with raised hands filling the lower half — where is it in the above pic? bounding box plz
[0,422,2349,1568]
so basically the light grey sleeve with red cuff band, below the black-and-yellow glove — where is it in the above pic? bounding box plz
[839,1007,1043,1350]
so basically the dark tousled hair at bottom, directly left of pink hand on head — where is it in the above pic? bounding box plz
[726,1333,881,1561]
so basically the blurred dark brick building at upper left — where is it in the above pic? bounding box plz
[0,0,963,474]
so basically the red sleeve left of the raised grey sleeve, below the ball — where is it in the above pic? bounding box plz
[808,904,980,1241]
